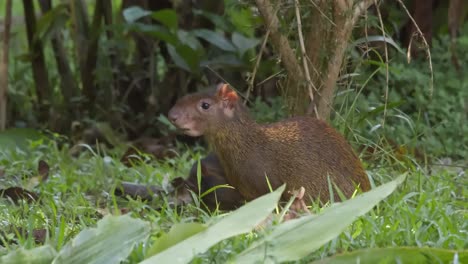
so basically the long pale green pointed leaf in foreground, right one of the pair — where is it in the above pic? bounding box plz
[234,175,405,263]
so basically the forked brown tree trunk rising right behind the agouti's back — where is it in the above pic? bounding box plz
[256,0,374,119]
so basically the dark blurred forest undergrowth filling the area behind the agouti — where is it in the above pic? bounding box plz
[0,0,468,160]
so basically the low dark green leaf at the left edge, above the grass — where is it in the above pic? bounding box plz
[0,128,47,151]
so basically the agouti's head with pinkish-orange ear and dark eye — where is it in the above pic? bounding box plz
[168,83,244,137]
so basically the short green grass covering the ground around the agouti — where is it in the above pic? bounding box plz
[0,132,468,263]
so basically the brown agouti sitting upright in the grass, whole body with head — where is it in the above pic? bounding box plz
[169,84,370,202]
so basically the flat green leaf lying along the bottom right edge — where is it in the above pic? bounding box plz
[313,247,468,264]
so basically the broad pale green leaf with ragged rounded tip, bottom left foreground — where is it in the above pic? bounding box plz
[53,215,150,263]
